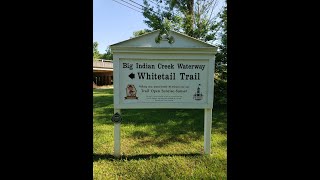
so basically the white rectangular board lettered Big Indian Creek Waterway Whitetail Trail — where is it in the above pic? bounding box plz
[114,59,213,109]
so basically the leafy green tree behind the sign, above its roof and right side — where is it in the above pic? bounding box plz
[143,0,227,104]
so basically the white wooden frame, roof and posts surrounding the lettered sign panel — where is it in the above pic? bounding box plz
[111,30,217,157]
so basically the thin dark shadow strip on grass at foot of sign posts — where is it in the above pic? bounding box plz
[93,153,202,161]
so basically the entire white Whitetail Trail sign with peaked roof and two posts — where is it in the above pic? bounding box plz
[111,31,216,157]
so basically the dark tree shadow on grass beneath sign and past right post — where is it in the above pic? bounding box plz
[122,109,227,147]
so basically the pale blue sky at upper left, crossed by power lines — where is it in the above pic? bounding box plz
[93,0,224,54]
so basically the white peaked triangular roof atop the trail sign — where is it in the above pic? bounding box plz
[110,30,216,48]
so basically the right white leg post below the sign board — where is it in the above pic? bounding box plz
[204,109,212,154]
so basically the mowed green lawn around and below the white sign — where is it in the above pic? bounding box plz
[93,89,227,180]
